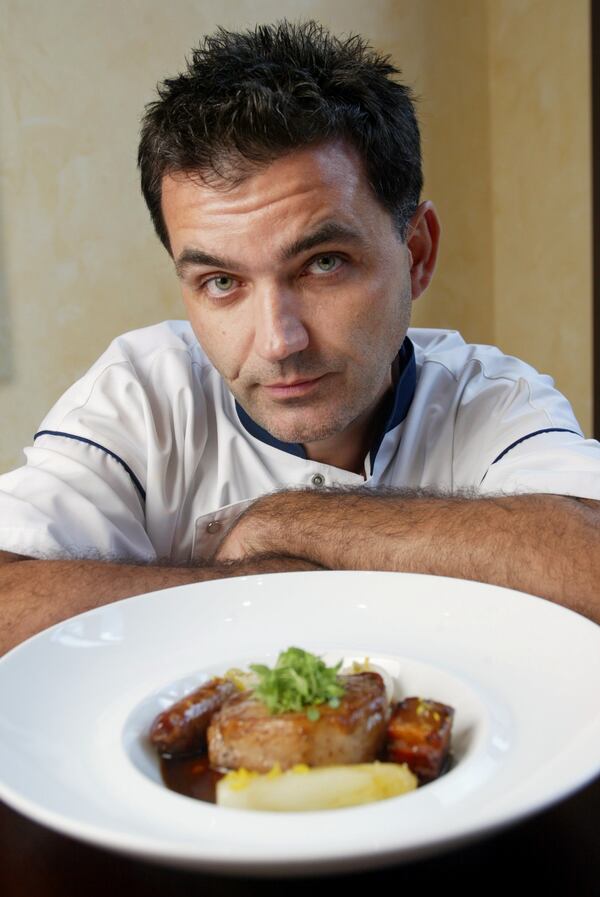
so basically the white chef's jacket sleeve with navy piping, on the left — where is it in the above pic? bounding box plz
[0,361,156,561]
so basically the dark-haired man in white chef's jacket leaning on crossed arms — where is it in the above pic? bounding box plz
[0,23,600,648]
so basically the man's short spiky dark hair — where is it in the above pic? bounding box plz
[138,21,423,251]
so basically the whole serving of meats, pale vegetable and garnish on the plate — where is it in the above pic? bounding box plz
[150,648,453,811]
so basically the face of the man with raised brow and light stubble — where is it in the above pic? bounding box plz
[162,142,418,456]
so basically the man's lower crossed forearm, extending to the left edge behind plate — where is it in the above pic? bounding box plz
[0,556,324,655]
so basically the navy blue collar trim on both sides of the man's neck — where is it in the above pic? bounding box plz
[235,337,417,469]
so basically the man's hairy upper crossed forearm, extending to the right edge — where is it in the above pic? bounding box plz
[217,489,600,622]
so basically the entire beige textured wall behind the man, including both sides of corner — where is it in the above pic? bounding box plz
[0,0,591,471]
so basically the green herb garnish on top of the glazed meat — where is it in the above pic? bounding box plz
[250,648,344,720]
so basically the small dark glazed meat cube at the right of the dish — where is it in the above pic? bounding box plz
[386,698,454,784]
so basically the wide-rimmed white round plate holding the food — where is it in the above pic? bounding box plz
[0,572,600,875]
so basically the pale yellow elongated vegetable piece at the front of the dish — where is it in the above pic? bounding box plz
[217,762,417,812]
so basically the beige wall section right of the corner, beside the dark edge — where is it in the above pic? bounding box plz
[488,0,592,432]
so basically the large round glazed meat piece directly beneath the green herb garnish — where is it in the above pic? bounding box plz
[208,673,388,772]
